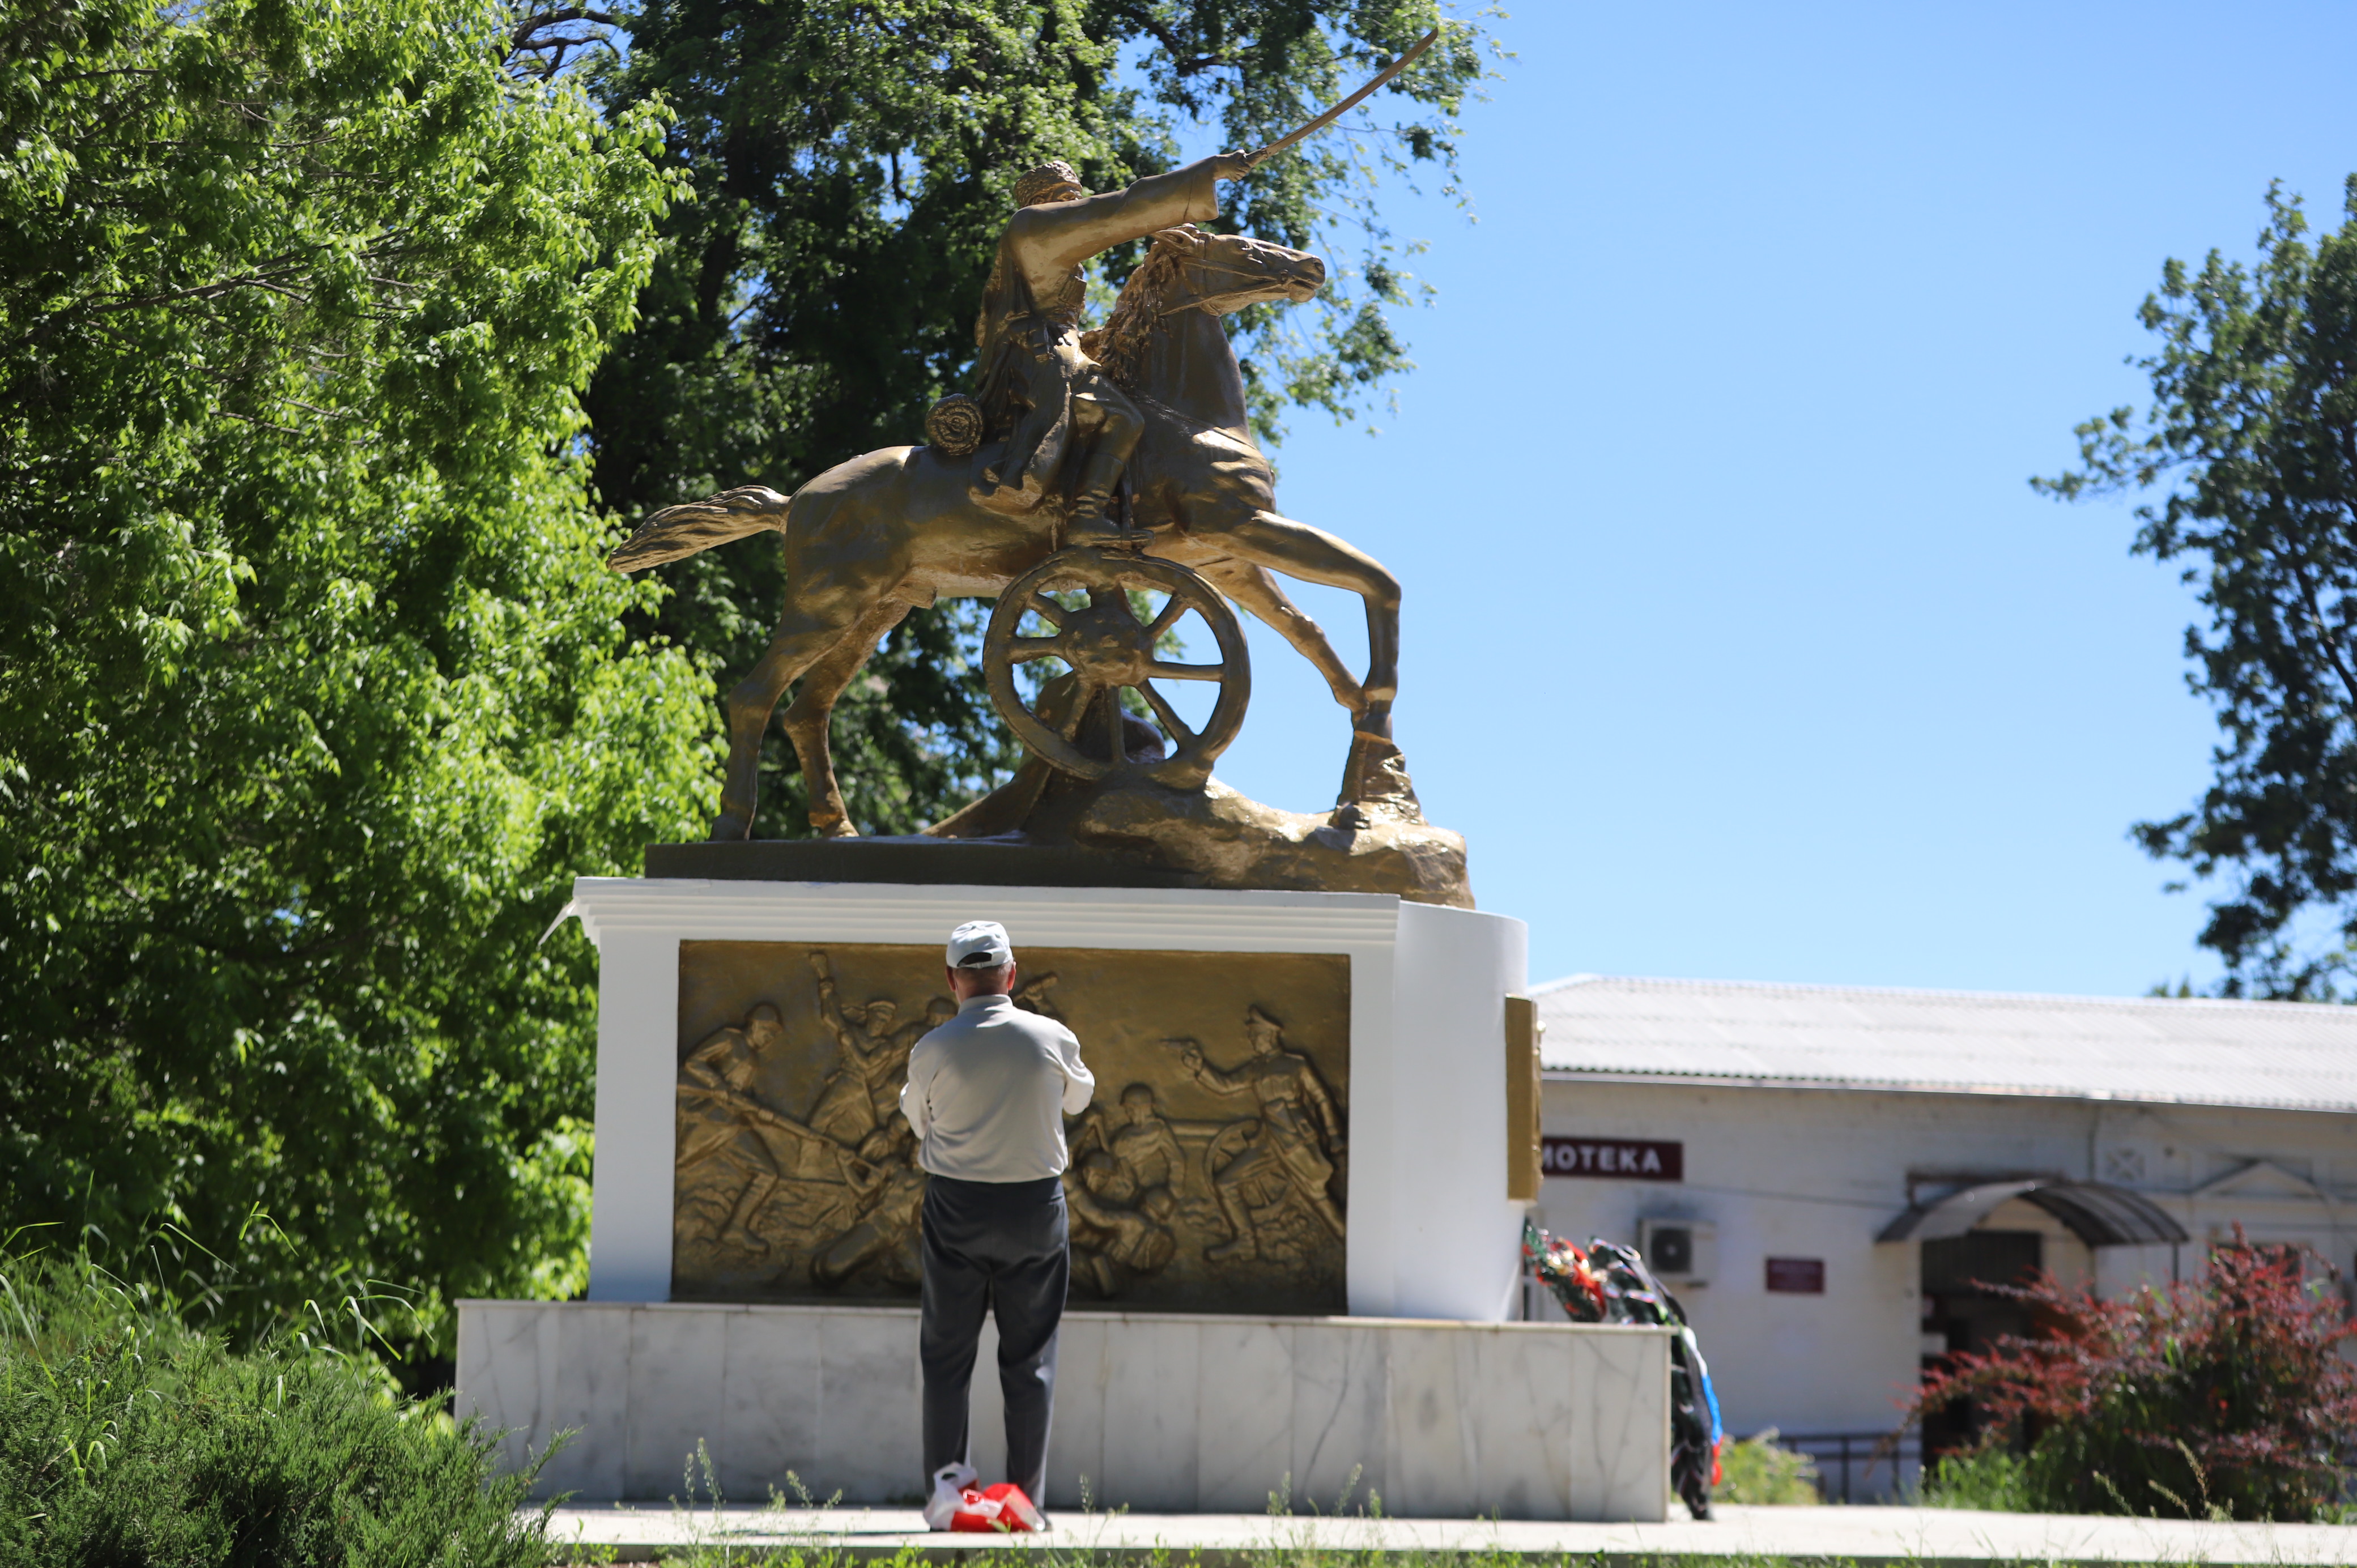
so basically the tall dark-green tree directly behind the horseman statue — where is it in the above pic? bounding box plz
[577,0,1483,837]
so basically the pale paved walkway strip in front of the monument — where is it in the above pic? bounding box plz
[549,1505,2357,1566]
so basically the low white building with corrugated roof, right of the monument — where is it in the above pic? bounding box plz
[1537,976,2357,1497]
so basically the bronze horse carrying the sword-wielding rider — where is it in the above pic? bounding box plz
[606,227,1414,840]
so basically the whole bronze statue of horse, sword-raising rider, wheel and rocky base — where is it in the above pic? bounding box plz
[608,154,1473,908]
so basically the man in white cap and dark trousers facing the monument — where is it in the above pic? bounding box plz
[900,919,1096,1530]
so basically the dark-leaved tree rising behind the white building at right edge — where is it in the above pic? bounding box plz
[2032,174,2357,998]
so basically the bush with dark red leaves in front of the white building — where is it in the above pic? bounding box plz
[1907,1226,2357,1519]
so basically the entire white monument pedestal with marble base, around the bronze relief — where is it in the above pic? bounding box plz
[457,877,1669,1521]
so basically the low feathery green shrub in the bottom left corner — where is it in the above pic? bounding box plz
[0,1259,556,1568]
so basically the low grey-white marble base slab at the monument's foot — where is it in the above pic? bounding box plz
[457,1302,1671,1521]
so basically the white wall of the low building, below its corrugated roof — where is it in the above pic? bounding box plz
[1539,1075,2357,1480]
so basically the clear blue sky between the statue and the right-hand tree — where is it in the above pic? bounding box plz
[1188,0,2357,992]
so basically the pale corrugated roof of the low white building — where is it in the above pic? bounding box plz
[1534,974,2357,1110]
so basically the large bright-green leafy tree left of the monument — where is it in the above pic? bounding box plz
[0,0,712,1349]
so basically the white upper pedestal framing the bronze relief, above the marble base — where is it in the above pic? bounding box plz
[573,877,1528,1323]
